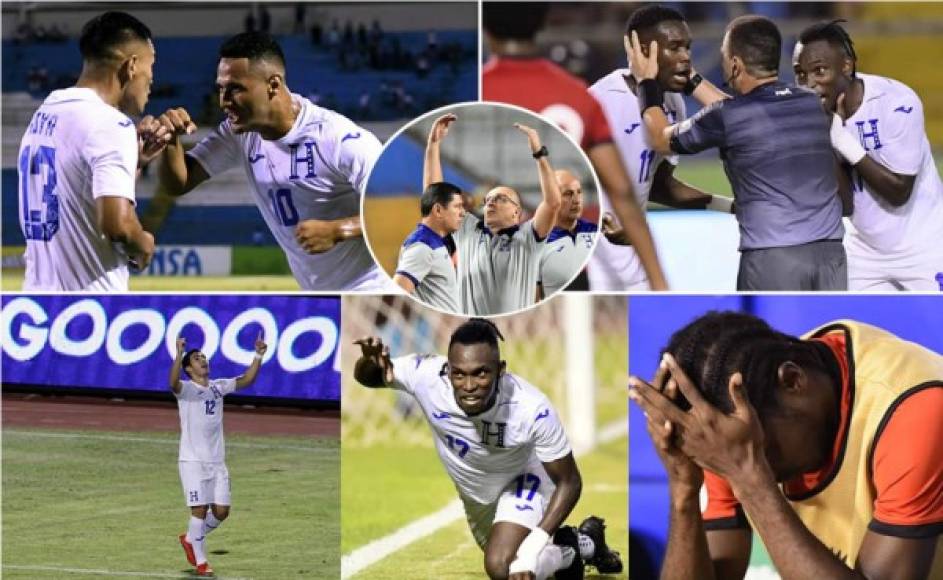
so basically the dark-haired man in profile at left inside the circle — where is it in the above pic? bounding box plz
[393,182,465,313]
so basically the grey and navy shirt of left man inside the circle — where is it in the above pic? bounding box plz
[396,224,461,312]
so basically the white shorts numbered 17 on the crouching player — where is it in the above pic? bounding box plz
[462,469,557,550]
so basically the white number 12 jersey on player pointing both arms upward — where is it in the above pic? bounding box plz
[174,379,236,462]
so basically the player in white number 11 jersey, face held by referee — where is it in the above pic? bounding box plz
[589,4,733,291]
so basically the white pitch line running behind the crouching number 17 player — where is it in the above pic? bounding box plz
[341,417,629,580]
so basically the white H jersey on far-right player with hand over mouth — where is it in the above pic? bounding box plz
[845,73,943,284]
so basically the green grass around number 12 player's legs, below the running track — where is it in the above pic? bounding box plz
[2,428,340,580]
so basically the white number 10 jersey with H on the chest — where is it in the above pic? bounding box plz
[188,95,387,291]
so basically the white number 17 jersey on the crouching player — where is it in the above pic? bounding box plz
[391,354,570,504]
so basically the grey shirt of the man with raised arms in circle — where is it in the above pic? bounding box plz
[453,214,544,316]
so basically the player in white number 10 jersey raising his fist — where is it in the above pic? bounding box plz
[159,32,387,291]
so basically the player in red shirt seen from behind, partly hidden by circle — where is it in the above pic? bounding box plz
[481,2,668,290]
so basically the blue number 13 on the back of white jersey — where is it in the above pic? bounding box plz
[19,145,59,242]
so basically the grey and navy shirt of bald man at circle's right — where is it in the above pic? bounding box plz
[540,219,599,297]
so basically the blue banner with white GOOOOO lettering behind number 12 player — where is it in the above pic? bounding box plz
[0,296,340,401]
